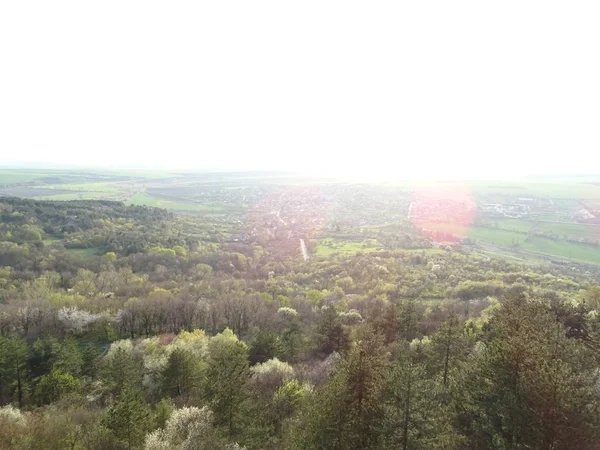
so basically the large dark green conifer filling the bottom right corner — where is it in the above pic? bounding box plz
[458,294,600,450]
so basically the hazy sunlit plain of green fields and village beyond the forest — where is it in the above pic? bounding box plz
[0,169,600,264]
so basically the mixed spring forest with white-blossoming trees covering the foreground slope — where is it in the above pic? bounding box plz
[0,197,600,450]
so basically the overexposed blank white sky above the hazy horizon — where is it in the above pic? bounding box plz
[0,0,600,179]
